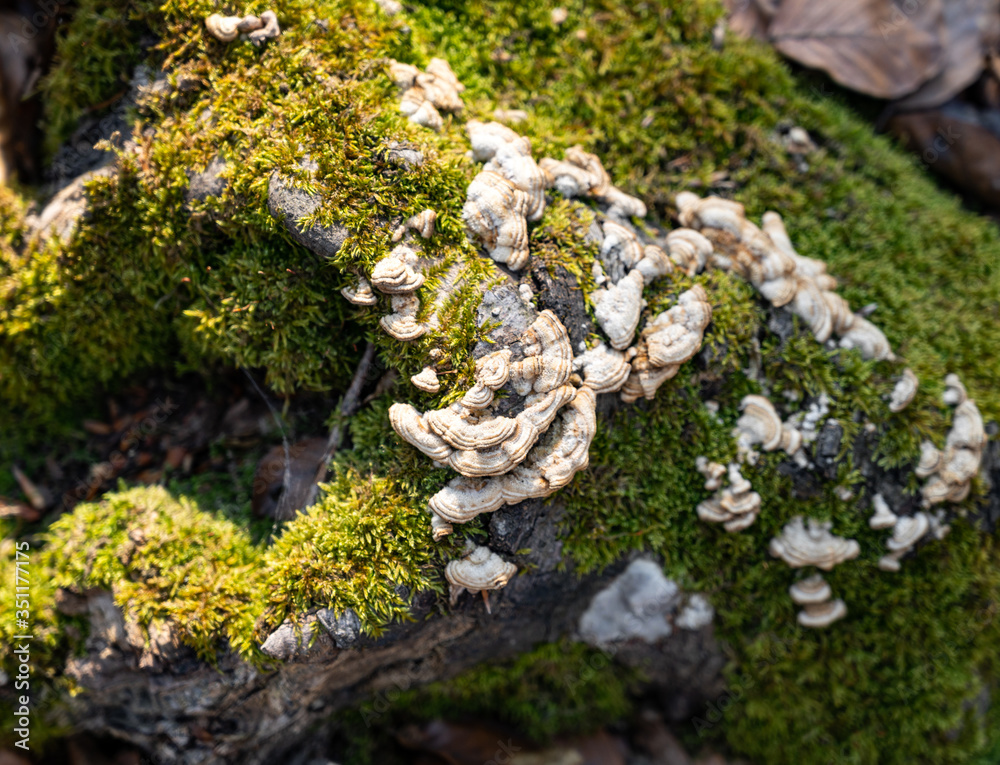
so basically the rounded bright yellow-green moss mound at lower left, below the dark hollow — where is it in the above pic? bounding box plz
[42,488,259,659]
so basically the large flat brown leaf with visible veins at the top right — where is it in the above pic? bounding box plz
[768,0,944,98]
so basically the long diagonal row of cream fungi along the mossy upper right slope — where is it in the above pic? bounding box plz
[677,197,895,360]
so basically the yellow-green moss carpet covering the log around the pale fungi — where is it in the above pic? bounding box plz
[0,0,1000,762]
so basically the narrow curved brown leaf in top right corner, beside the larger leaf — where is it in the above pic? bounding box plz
[896,0,1000,109]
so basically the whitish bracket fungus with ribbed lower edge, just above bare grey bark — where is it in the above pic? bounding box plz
[462,170,531,271]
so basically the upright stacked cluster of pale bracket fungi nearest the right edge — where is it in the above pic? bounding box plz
[915,374,986,507]
